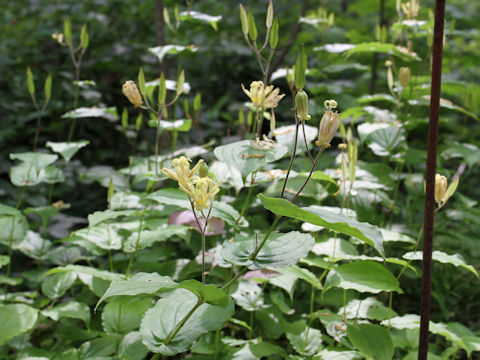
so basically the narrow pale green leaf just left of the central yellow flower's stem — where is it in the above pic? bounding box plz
[123,225,190,253]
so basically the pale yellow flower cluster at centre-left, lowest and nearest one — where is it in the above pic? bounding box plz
[162,156,220,211]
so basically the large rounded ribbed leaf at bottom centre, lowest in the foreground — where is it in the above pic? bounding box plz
[140,289,234,356]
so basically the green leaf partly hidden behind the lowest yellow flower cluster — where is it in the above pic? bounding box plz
[148,189,240,228]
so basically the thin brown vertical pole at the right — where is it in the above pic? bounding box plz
[418,0,445,360]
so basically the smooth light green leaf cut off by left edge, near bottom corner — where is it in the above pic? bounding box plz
[0,304,38,345]
